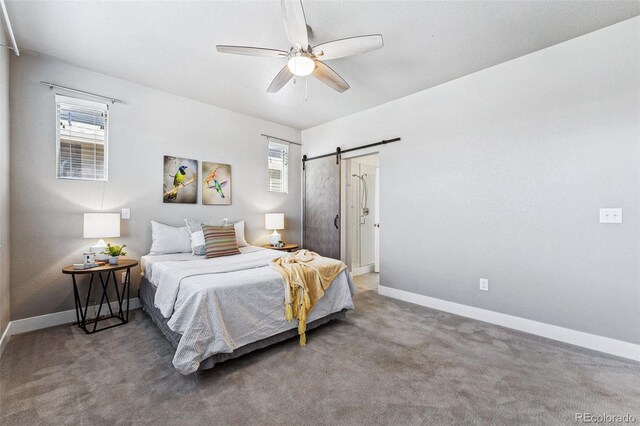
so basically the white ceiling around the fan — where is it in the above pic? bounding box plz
[7,0,640,129]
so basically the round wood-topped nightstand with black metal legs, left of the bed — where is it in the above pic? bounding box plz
[62,259,138,334]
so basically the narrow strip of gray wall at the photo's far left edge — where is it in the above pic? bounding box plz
[0,31,12,337]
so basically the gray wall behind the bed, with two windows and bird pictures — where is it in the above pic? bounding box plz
[11,55,300,320]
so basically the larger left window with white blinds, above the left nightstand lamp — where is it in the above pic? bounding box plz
[56,95,109,181]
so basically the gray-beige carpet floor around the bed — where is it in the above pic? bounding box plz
[0,275,640,425]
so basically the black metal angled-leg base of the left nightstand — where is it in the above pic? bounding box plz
[71,268,131,334]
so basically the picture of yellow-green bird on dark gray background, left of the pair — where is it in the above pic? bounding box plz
[162,155,198,204]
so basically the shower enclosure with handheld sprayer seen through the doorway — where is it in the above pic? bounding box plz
[346,156,378,275]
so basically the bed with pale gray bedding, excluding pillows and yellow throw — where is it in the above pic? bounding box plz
[139,246,355,374]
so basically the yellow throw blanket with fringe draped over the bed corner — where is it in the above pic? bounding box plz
[270,250,347,346]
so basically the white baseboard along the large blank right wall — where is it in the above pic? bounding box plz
[378,286,640,361]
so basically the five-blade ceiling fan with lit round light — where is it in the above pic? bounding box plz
[216,0,383,93]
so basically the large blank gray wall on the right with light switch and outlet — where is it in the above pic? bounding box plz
[302,18,640,344]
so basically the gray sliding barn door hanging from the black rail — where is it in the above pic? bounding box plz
[303,155,340,259]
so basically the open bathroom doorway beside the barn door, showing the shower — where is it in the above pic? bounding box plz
[342,153,380,290]
